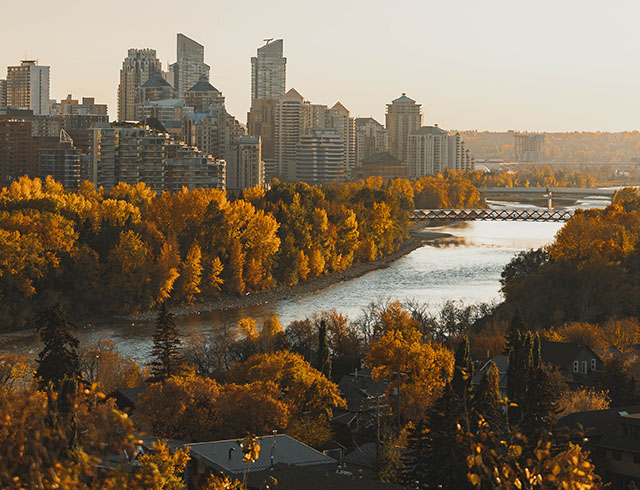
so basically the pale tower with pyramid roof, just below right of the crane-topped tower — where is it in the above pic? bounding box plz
[272,88,310,181]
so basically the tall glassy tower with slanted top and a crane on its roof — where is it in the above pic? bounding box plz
[251,39,287,104]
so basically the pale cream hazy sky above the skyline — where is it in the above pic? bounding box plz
[0,0,640,131]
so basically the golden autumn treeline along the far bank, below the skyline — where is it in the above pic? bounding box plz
[0,173,482,329]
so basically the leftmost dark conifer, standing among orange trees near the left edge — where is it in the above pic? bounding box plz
[36,304,80,390]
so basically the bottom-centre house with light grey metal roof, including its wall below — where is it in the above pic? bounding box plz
[185,434,338,490]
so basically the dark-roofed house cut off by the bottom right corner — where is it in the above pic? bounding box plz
[558,406,640,490]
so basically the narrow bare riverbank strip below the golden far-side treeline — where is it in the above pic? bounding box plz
[116,235,438,322]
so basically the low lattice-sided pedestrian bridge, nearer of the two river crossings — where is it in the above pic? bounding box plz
[410,208,574,222]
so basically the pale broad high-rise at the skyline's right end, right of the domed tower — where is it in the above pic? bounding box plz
[408,125,475,178]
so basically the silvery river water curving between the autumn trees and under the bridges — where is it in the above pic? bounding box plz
[0,198,609,361]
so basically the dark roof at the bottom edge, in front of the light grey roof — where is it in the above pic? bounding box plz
[248,464,405,490]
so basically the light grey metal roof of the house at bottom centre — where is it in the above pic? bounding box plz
[187,434,337,474]
